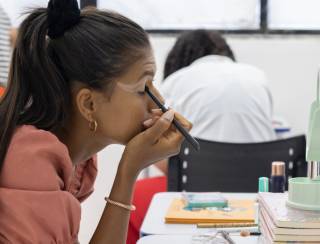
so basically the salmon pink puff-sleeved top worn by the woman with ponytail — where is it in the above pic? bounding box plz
[0,125,97,244]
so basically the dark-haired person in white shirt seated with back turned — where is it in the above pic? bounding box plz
[160,30,276,143]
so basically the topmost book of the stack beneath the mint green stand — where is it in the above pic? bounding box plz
[258,192,320,229]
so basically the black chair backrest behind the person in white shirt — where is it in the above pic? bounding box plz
[168,135,307,192]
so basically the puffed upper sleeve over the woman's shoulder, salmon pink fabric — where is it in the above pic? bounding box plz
[0,125,72,190]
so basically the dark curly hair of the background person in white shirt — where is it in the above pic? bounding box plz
[164,30,235,79]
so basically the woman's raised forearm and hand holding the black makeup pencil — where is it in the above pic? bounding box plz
[90,111,191,244]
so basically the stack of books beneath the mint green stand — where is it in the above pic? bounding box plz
[258,192,320,243]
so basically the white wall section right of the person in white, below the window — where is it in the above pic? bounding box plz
[226,36,320,134]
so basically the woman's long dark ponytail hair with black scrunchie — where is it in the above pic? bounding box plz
[0,0,150,170]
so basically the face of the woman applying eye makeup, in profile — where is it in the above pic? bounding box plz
[93,51,163,145]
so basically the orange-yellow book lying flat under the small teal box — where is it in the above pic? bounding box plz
[165,199,255,224]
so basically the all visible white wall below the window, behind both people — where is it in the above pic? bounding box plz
[79,35,320,243]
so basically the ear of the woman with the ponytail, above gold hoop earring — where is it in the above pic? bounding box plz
[75,88,97,121]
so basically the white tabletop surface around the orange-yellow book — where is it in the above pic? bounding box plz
[140,192,257,235]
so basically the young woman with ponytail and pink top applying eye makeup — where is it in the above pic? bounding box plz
[0,0,191,244]
